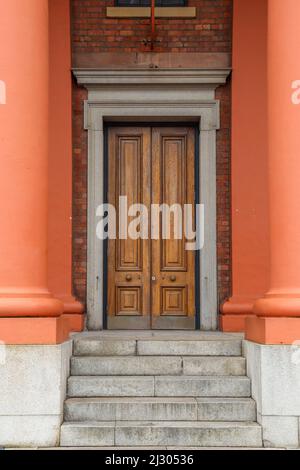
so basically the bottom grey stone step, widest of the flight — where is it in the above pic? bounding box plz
[61,421,262,447]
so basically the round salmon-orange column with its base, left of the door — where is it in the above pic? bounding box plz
[0,0,74,344]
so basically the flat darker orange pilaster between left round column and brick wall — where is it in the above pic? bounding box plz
[48,0,83,314]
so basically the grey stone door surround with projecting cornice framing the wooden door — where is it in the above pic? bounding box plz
[73,69,230,331]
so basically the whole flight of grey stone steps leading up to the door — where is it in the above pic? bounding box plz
[61,332,262,449]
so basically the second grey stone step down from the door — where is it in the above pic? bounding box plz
[71,356,246,375]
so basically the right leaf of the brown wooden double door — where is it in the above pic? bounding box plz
[151,127,195,329]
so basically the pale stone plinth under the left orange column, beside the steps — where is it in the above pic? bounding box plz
[0,340,72,448]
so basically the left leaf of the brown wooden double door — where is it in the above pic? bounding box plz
[107,127,151,330]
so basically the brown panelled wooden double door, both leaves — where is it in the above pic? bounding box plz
[106,126,196,330]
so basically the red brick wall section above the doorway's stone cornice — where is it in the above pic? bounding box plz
[72,0,232,52]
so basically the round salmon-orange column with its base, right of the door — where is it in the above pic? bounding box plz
[247,0,300,344]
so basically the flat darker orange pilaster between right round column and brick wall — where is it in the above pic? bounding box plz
[220,0,269,331]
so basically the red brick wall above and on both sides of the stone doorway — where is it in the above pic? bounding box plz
[72,0,232,312]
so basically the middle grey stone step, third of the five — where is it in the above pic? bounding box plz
[68,376,250,398]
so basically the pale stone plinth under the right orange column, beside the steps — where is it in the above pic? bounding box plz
[244,336,300,448]
